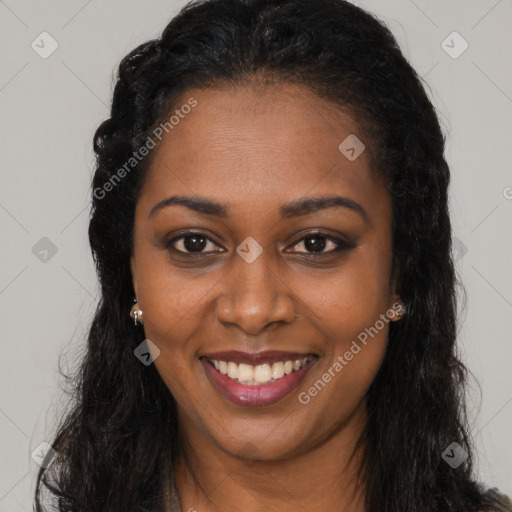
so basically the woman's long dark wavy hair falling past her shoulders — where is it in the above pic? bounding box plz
[36,0,507,512]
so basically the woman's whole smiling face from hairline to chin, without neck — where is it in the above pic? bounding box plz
[131,85,398,460]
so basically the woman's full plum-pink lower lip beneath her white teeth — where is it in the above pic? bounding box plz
[201,358,316,407]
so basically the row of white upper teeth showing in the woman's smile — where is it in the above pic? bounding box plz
[210,357,309,386]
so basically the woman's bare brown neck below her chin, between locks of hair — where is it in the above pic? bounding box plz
[174,405,365,512]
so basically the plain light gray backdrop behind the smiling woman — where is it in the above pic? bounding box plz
[0,0,512,506]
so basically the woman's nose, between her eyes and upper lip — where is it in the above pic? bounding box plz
[217,251,296,335]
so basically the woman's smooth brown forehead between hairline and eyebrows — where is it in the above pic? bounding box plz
[138,84,383,220]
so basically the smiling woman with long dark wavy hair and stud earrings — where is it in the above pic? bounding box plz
[36,0,512,512]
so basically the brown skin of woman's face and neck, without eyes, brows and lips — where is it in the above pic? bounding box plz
[131,84,399,512]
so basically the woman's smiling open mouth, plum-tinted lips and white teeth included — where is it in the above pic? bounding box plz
[200,352,318,406]
